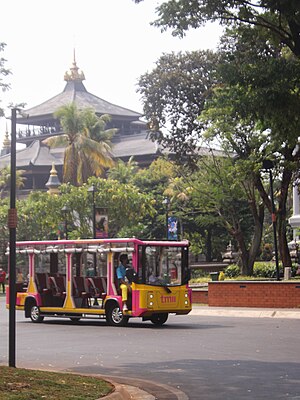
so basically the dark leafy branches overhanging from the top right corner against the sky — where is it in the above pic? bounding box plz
[135,0,300,58]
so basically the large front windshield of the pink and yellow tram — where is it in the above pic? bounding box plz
[138,246,188,286]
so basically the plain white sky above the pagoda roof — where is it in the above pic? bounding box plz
[0,0,221,146]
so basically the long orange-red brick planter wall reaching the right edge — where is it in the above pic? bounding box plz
[208,281,300,308]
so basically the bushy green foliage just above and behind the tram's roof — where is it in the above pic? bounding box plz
[0,178,154,243]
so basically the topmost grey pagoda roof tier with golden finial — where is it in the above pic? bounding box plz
[17,57,142,125]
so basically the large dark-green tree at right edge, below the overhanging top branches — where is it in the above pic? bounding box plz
[201,27,300,266]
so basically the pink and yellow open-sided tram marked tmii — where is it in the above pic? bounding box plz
[6,238,192,326]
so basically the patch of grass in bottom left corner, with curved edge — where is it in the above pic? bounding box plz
[0,367,113,400]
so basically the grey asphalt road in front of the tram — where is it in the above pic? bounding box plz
[0,297,300,400]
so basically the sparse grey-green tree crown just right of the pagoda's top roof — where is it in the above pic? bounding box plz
[138,51,218,163]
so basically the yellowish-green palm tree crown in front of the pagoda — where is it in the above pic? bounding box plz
[45,103,116,186]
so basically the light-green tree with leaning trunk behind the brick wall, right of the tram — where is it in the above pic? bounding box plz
[166,151,264,275]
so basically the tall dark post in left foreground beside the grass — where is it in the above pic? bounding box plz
[8,108,18,367]
